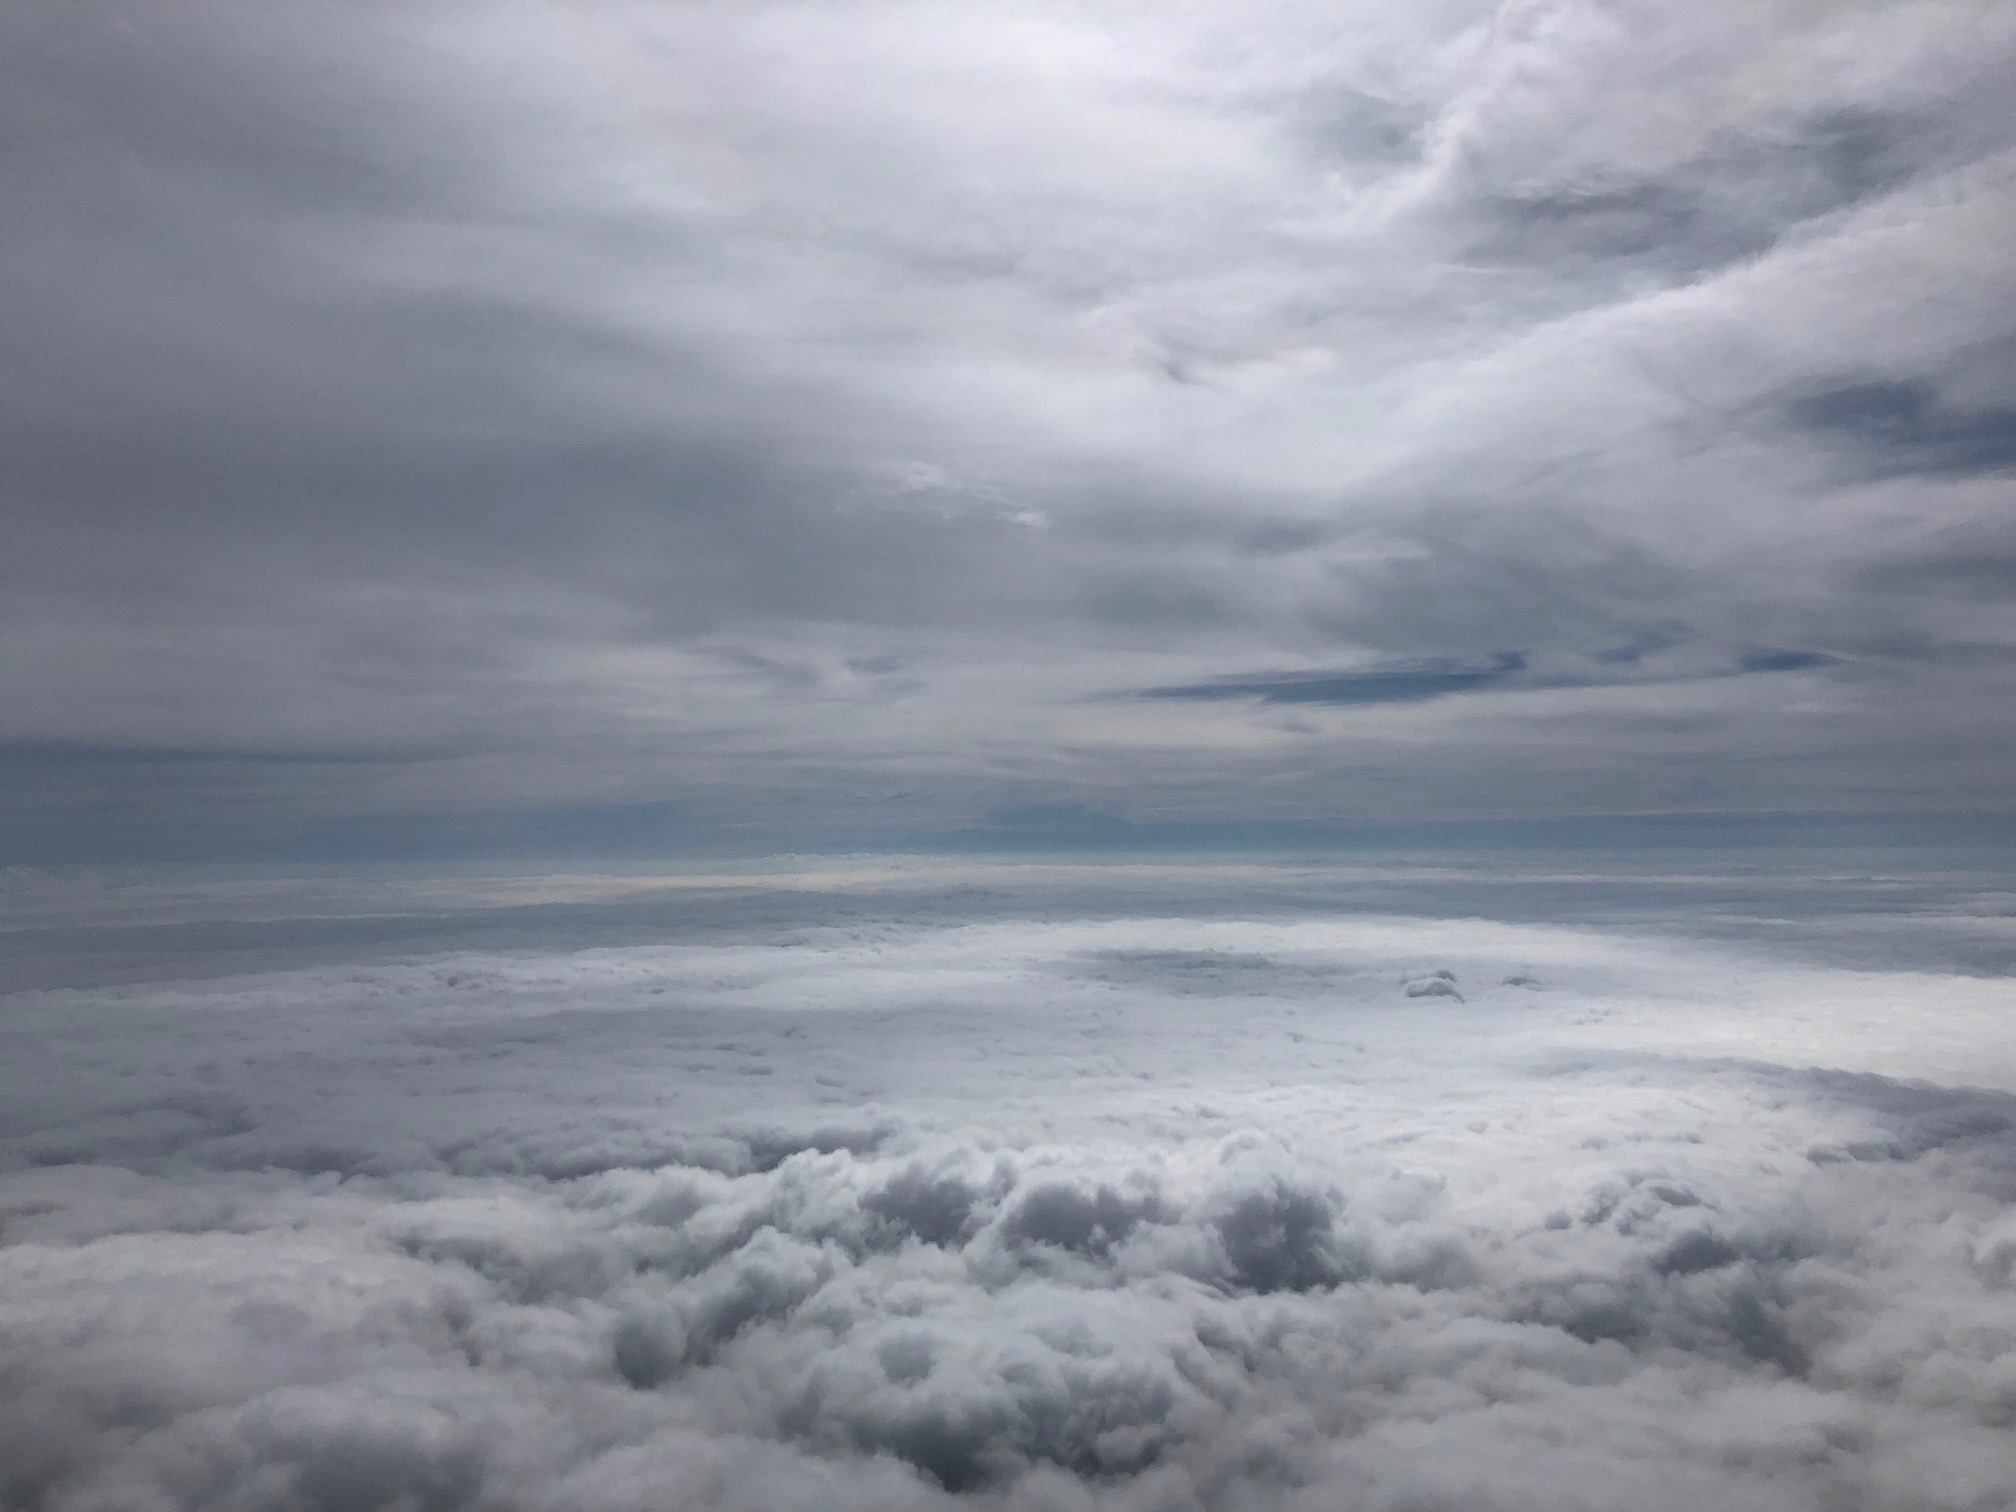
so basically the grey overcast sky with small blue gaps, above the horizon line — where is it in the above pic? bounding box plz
[0,0,2016,857]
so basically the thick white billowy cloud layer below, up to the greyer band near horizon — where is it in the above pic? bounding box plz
[0,869,2016,1512]
